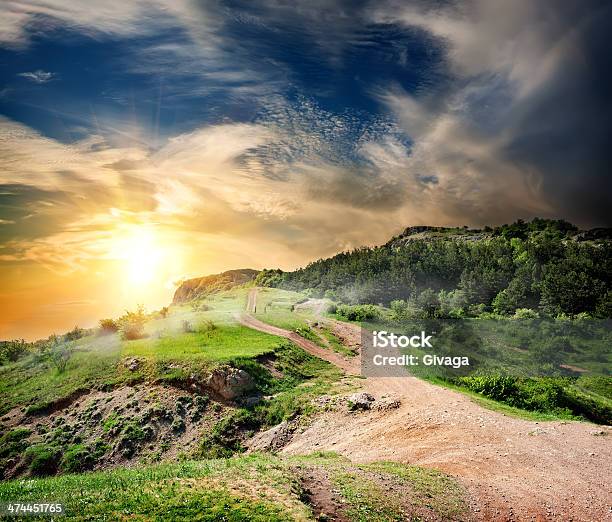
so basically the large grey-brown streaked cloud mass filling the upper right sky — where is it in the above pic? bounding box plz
[377,0,612,226]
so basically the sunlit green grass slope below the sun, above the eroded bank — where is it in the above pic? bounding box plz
[0,289,279,415]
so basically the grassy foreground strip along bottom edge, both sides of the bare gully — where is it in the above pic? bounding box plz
[0,454,466,521]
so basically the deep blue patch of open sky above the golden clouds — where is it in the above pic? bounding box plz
[0,2,442,148]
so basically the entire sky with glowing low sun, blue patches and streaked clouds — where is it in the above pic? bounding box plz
[0,0,612,339]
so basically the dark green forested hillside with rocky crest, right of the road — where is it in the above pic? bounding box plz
[256,218,612,317]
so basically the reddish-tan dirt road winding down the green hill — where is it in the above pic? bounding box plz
[243,293,612,522]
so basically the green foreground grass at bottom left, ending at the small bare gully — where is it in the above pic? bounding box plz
[0,456,308,522]
